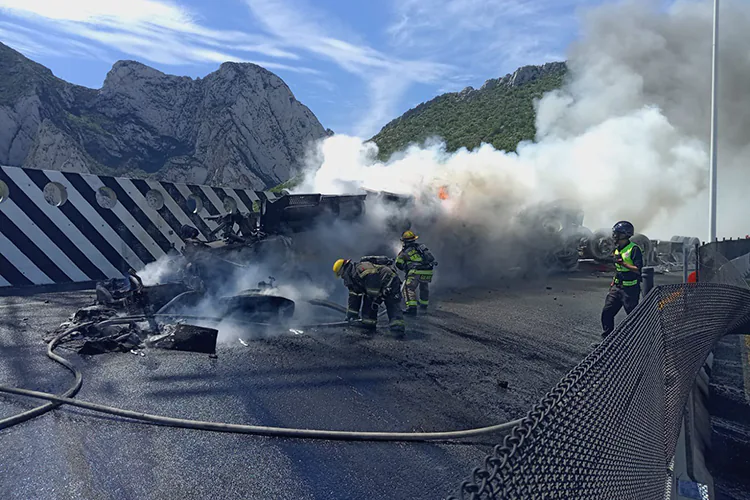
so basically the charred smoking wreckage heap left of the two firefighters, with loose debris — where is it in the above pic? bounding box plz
[52,189,374,355]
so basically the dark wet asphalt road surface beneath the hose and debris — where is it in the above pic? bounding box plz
[0,273,680,500]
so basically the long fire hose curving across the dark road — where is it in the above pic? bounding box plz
[0,300,523,442]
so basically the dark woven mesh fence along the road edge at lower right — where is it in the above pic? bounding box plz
[451,242,750,500]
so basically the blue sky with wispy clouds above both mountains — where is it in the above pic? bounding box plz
[0,0,604,138]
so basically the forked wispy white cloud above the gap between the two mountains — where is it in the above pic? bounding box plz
[246,0,450,137]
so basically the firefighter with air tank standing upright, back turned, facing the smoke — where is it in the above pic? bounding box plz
[396,231,437,316]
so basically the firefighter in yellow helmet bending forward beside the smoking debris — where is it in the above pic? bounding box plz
[333,257,405,333]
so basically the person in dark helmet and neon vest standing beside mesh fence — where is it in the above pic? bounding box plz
[602,221,643,339]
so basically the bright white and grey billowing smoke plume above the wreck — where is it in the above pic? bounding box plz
[297,1,750,243]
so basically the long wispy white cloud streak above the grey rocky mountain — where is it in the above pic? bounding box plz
[0,0,317,74]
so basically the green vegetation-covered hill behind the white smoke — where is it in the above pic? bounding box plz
[370,62,567,159]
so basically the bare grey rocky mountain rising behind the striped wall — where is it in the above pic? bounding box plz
[0,43,330,189]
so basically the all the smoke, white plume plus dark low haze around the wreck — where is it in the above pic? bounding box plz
[140,1,750,326]
